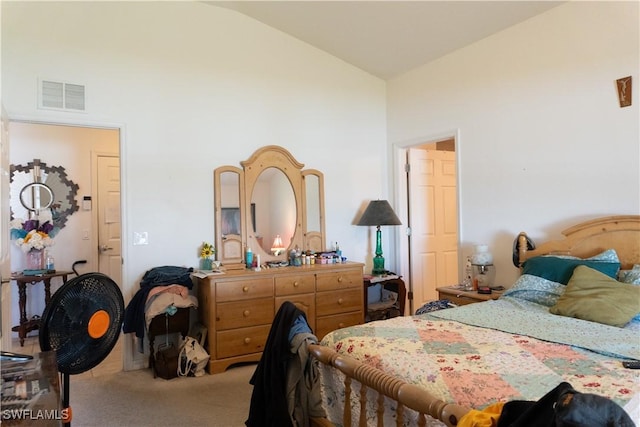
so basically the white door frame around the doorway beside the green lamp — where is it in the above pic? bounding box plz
[392,129,464,314]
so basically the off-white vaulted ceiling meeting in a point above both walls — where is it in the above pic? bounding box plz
[206,0,565,80]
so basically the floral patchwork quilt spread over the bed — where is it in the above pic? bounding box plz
[322,309,640,409]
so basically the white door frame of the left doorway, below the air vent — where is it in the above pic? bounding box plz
[1,113,127,362]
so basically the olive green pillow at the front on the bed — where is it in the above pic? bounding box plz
[549,265,640,327]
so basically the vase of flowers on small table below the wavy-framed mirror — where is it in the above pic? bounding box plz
[10,219,55,270]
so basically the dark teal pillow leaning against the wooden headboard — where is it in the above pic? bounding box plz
[522,256,620,285]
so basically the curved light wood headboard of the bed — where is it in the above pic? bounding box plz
[518,215,640,270]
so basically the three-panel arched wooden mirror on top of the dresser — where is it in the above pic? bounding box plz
[214,145,325,269]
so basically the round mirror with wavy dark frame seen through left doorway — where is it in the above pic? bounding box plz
[10,159,79,229]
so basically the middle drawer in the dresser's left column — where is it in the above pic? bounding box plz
[216,298,275,331]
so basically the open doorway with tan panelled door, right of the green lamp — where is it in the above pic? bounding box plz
[397,135,459,313]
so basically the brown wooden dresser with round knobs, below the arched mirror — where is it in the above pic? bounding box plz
[197,262,364,374]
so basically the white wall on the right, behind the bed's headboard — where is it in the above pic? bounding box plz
[388,2,640,284]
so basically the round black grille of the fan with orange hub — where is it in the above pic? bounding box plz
[39,273,124,375]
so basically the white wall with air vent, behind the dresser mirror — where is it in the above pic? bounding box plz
[0,2,388,368]
